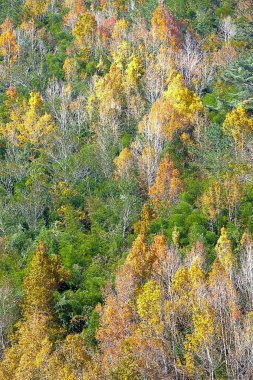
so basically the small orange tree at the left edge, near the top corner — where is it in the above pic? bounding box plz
[0,17,20,65]
